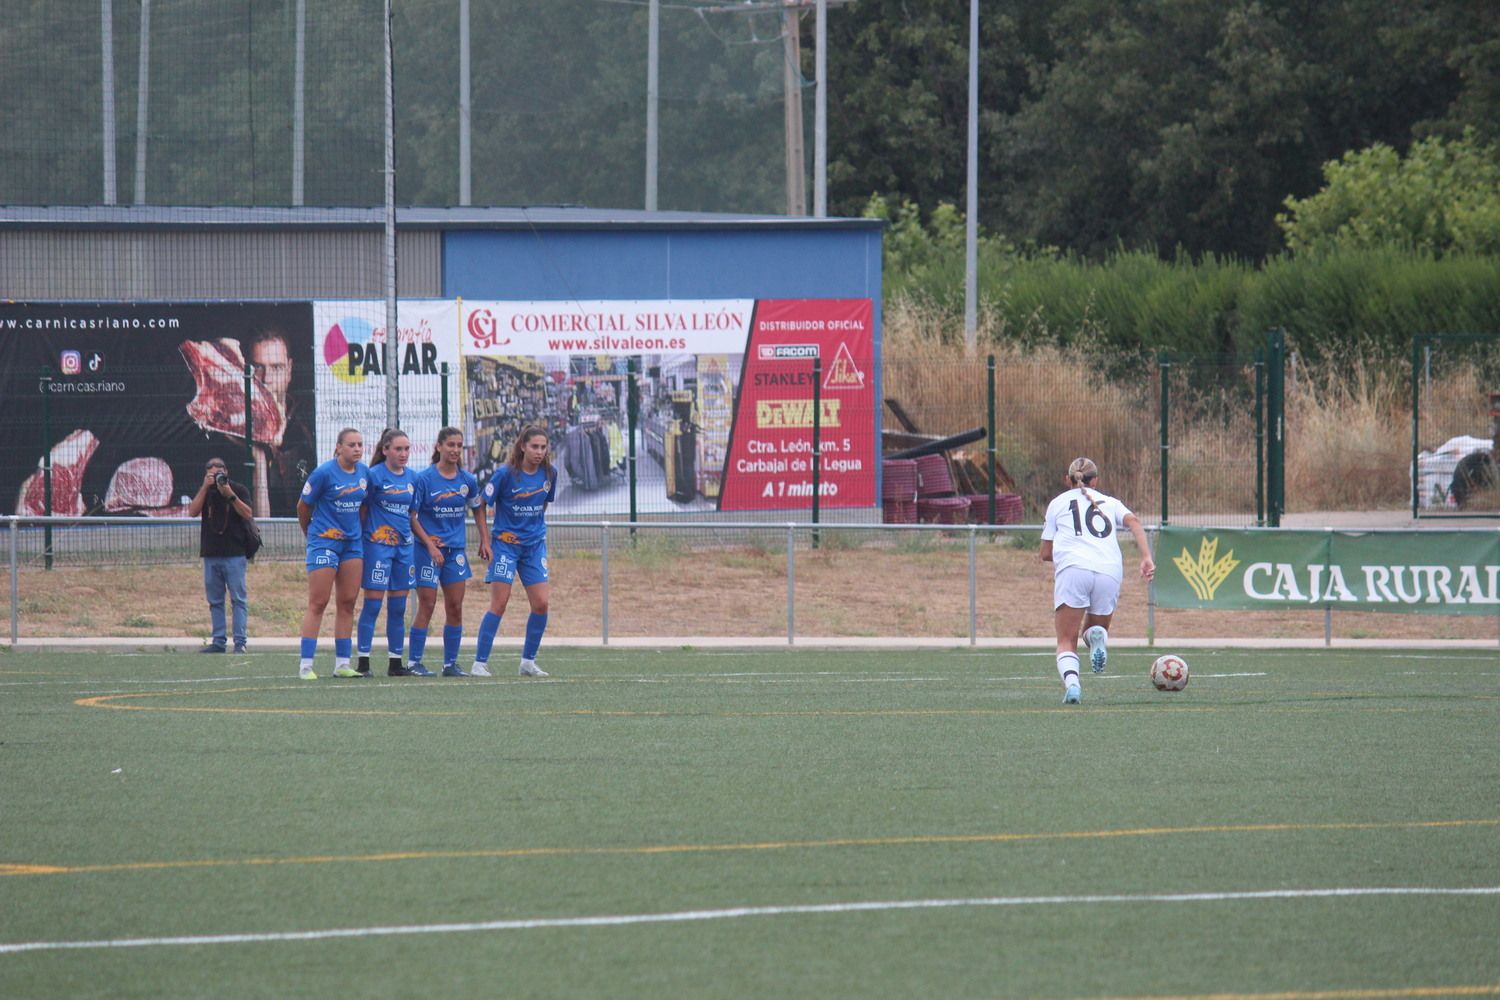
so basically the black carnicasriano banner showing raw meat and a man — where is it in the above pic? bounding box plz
[0,303,317,517]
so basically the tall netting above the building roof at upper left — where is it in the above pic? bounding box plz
[0,0,812,213]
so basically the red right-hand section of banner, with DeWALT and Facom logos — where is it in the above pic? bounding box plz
[719,298,879,510]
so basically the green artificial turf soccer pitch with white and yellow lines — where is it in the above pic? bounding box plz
[0,648,1500,999]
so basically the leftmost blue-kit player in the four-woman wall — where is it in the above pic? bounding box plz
[297,427,371,681]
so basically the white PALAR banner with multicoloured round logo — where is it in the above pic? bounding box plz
[312,298,461,469]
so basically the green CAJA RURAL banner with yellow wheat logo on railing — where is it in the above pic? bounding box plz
[1154,526,1500,615]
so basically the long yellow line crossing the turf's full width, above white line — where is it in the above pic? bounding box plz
[0,819,1500,877]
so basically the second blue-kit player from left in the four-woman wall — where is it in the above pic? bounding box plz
[354,427,417,678]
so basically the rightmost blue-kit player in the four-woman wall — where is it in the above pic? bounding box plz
[471,424,558,678]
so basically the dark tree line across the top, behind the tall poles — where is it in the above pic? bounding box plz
[0,0,1500,261]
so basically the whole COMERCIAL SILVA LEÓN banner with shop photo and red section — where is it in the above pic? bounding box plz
[462,298,878,513]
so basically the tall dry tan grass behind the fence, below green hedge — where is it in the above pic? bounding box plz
[885,298,1500,517]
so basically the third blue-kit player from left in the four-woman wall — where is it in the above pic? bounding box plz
[408,427,489,678]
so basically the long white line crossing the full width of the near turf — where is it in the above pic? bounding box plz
[0,886,1500,954]
